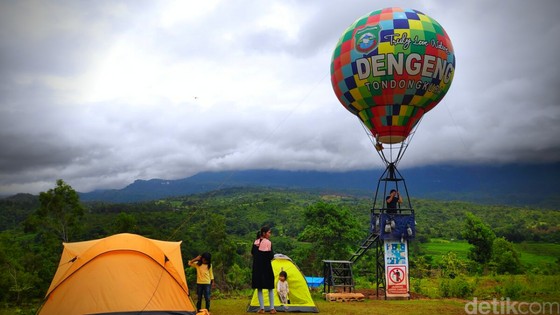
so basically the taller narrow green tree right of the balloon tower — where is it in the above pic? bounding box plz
[462,212,496,264]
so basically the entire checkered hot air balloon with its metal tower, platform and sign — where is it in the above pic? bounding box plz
[325,8,455,298]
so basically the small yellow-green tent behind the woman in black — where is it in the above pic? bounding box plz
[247,254,319,313]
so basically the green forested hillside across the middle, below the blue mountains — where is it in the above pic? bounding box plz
[0,188,560,242]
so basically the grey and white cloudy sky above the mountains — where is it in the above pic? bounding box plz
[0,0,560,195]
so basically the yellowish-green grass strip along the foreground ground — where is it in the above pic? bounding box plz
[4,275,560,315]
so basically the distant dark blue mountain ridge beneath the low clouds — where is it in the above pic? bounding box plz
[80,163,560,209]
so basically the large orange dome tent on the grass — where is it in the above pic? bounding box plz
[39,234,196,315]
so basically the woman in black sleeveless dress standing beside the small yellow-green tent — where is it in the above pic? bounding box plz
[251,226,276,314]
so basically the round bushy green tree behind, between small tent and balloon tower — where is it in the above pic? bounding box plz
[299,202,363,272]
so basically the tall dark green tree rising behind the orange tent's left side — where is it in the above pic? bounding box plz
[37,179,84,242]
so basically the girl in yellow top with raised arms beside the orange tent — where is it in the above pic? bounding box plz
[188,253,214,312]
